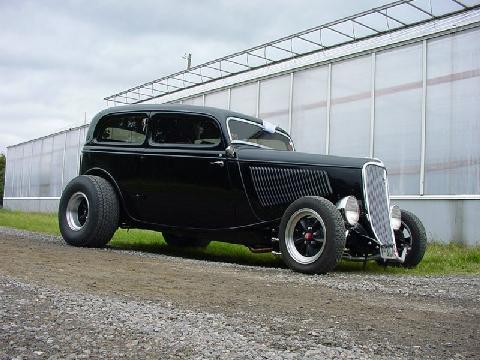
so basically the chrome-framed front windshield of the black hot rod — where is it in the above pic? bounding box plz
[228,118,294,151]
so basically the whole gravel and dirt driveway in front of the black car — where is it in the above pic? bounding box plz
[0,227,480,359]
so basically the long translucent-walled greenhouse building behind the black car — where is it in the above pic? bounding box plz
[4,0,480,245]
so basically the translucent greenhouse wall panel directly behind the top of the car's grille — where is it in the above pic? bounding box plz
[373,44,423,194]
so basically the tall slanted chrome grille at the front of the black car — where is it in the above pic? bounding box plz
[362,162,398,250]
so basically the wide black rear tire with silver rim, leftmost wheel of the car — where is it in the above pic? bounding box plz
[58,175,120,247]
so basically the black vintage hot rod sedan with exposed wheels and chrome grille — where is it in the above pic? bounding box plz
[59,104,426,273]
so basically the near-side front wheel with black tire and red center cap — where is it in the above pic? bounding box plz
[279,196,346,274]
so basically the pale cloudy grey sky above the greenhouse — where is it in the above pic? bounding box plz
[0,0,391,152]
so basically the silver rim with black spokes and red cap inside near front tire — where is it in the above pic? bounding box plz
[285,208,327,265]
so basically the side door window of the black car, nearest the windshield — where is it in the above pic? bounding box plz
[152,114,221,146]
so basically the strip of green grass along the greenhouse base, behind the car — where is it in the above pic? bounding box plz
[0,209,480,275]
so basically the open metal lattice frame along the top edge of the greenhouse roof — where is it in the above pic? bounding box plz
[104,0,480,105]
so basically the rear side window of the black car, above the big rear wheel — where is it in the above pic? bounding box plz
[95,114,148,144]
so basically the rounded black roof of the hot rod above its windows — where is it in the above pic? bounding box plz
[87,104,288,140]
